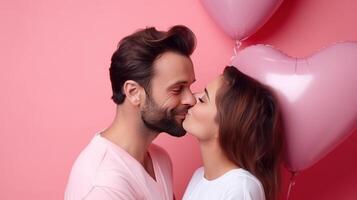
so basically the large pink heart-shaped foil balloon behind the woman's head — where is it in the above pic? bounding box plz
[232,42,357,172]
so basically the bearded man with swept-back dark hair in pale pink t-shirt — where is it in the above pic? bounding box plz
[65,26,196,200]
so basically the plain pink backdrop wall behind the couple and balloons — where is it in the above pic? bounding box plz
[0,0,357,200]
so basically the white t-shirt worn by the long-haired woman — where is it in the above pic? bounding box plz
[183,167,265,200]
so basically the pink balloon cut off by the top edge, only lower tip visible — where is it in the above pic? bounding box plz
[201,0,283,40]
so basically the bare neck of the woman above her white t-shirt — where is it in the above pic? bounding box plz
[200,141,238,180]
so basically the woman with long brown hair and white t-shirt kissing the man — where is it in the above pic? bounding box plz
[183,67,282,200]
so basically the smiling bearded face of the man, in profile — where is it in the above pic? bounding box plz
[141,52,196,137]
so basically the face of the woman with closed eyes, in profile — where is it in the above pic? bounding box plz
[182,76,223,141]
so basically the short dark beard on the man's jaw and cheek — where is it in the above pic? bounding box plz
[141,96,187,137]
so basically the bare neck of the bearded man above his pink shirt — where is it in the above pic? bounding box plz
[98,107,158,167]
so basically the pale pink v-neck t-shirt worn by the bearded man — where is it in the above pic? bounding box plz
[64,134,173,200]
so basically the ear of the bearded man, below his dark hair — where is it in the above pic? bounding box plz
[123,80,142,106]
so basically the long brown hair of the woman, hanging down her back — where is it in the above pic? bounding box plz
[216,66,283,200]
